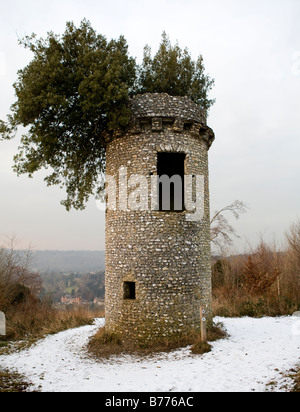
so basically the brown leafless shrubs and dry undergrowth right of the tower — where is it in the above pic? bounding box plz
[212,235,300,317]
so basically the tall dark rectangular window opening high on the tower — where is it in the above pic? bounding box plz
[157,153,186,212]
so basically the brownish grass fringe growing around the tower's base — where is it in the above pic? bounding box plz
[88,324,227,359]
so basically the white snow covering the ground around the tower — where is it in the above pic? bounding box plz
[0,317,300,392]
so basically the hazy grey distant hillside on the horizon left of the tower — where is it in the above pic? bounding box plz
[31,250,105,274]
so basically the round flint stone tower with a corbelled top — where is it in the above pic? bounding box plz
[106,94,214,341]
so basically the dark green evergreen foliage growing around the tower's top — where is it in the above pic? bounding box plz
[0,20,214,210]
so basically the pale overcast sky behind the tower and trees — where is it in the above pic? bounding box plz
[0,0,300,251]
